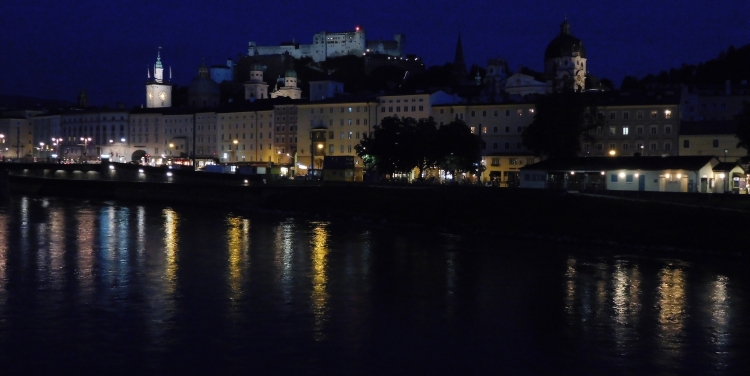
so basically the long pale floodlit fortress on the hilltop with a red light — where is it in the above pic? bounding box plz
[247,26,406,62]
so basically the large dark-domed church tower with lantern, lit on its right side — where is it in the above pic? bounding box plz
[544,20,586,91]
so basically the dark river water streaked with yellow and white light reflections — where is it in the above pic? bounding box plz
[0,196,750,375]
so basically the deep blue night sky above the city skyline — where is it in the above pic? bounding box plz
[0,0,750,106]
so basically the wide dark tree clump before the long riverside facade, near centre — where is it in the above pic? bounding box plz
[355,116,481,176]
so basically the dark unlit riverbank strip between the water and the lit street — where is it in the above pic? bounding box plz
[5,176,750,255]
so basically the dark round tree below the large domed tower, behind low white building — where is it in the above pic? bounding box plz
[521,91,604,158]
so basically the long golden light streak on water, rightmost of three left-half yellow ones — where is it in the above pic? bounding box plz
[310,222,328,341]
